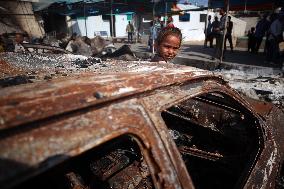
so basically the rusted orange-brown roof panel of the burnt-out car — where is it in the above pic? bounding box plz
[0,52,212,129]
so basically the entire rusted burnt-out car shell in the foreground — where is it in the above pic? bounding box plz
[0,58,284,189]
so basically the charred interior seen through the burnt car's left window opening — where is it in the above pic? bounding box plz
[13,136,154,189]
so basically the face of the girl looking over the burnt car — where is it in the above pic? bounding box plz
[155,35,180,61]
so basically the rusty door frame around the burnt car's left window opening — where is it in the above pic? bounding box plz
[0,100,184,188]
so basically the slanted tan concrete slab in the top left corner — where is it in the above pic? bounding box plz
[1,1,44,37]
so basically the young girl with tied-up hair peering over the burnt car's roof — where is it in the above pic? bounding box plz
[151,27,182,62]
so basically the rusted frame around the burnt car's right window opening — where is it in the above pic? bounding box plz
[143,79,265,188]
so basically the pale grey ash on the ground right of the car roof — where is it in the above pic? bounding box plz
[215,68,284,109]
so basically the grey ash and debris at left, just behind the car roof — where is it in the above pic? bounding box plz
[0,52,171,88]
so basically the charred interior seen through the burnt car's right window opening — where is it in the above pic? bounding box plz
[161,93,261,189]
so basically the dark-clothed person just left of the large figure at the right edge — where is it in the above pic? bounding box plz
[254,14,270,53]
